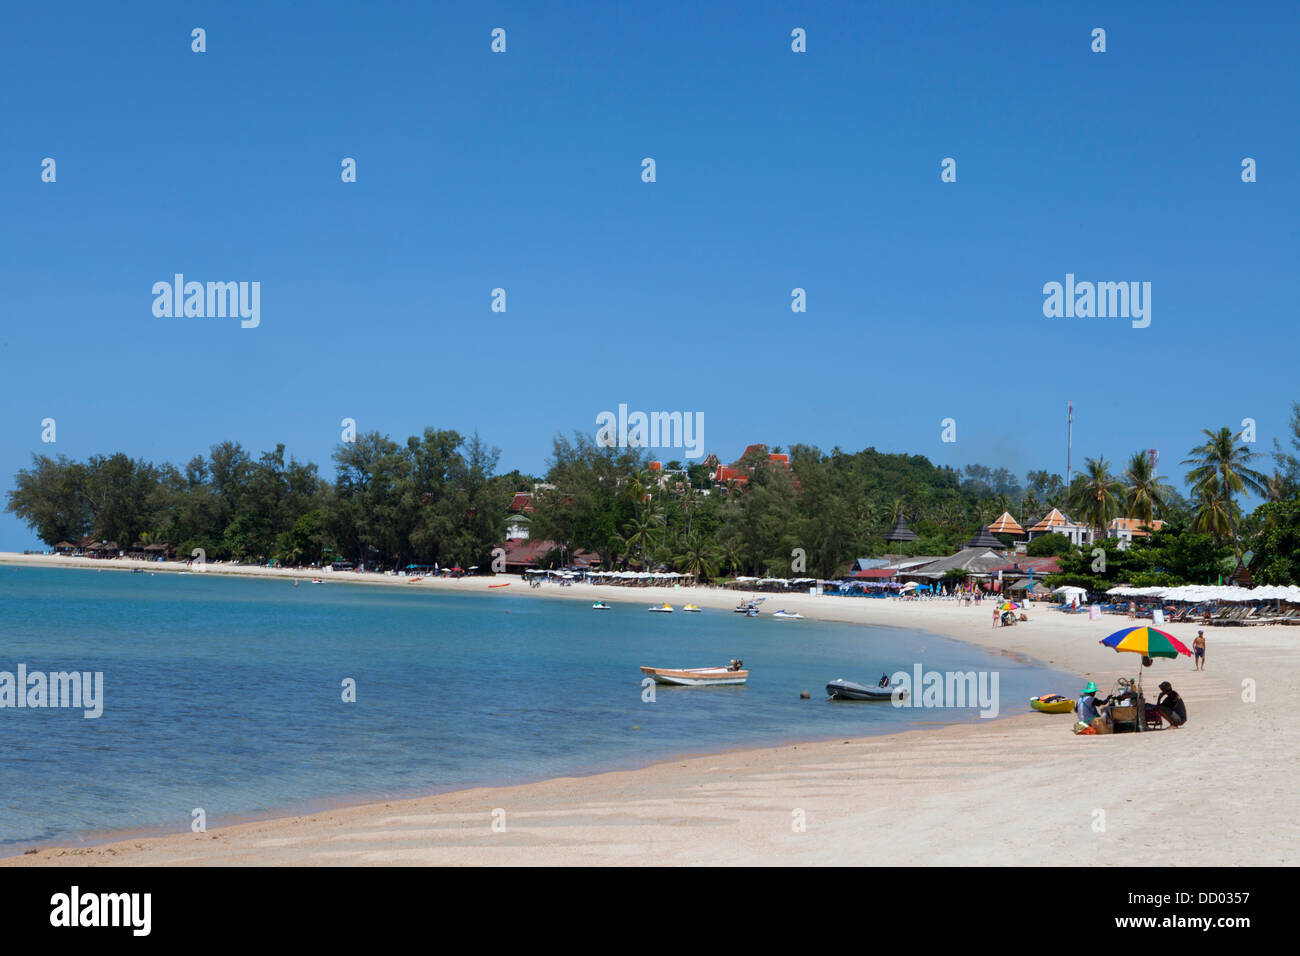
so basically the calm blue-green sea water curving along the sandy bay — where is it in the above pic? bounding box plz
[0,567,1067,855]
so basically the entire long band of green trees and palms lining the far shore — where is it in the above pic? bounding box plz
[8,406,1300,584]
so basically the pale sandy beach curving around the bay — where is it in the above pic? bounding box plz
[0,554,1300,866]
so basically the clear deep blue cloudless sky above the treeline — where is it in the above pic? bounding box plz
[0,3,1300,548]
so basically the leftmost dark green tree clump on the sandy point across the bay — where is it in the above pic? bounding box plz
[8,429,512,567]
